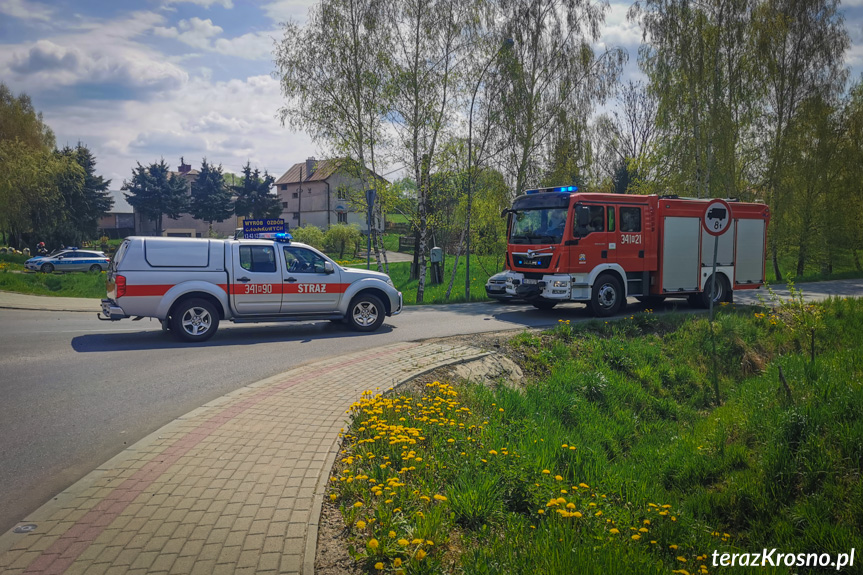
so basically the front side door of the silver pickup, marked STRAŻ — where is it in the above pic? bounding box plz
[282,245,347,314]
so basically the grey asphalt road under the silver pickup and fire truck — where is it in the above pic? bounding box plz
[0,280,863,531]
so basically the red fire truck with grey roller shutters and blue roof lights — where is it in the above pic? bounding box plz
[504,186,770,317]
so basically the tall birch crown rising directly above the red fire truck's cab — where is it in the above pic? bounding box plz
[501,0,626,194]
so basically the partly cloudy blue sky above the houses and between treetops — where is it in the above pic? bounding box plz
[0,0,863,189]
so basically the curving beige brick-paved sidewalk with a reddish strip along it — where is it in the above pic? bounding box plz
[0,343,485,575]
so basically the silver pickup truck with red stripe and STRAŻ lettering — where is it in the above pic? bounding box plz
[99,234,402,342]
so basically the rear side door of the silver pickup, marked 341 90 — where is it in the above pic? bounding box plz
[231,244,282,316]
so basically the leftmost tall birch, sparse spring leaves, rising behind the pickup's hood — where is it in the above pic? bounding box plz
[276,0,389,269]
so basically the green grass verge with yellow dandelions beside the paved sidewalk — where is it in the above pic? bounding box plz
[329,292,863,574]
